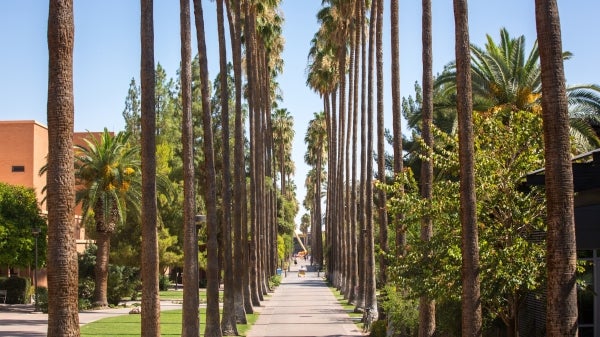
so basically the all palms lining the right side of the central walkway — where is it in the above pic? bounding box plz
[304,0,600,336]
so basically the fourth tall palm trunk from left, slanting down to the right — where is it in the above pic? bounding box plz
[194,0,221,337]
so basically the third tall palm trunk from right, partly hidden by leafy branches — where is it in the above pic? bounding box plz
[418,0,435,337]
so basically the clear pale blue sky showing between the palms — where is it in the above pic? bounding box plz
[0,0,600,223]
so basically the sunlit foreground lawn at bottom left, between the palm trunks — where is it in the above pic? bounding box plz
[81,308,258,337]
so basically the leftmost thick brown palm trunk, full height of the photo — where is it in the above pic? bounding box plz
[46,0,79,337]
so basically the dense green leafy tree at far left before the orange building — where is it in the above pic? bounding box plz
[0,183,47,267]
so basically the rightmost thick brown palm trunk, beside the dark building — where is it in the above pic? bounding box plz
[535,0,577,337]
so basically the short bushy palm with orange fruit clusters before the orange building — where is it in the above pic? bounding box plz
[75,128,140,307]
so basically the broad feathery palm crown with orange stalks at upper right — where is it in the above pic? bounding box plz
[436,28,600,151]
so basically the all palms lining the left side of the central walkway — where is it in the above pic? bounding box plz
[47,0,294,336]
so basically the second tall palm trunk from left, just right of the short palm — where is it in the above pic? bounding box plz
[140,0,160,337]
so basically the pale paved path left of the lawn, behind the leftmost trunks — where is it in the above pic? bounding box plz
[0,301,181,337]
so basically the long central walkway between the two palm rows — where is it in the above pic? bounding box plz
[247,261,364,337]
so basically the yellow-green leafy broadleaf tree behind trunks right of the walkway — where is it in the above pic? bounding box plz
[387,109,545,326]
